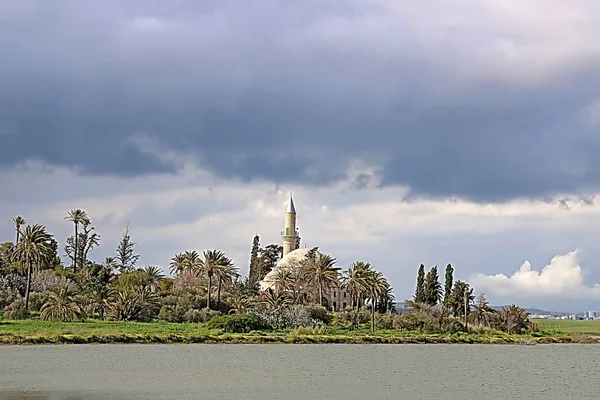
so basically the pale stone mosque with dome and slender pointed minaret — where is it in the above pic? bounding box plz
[259,193,352,311]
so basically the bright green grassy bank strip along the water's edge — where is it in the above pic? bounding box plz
[0,320,599,345]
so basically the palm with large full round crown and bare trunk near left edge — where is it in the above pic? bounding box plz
[13,224,52,309]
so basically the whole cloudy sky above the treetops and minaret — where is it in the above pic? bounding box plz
[0,0,600,311]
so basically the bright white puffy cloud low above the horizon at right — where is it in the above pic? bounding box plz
[469,250,600,299]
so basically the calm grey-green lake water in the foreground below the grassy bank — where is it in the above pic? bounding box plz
[0,345,600,400]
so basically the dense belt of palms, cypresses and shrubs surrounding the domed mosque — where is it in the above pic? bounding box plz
[0,209,564,343]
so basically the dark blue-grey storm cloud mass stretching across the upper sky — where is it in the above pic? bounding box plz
[0,0,600,201]
